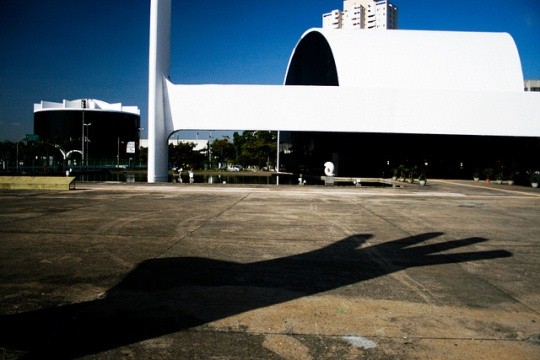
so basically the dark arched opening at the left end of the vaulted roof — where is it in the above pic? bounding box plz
[285,31,339,86]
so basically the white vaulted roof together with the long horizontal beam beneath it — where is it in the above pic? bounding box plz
[164,29,540,136]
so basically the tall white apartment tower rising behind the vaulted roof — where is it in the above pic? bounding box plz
[322,0,398,30]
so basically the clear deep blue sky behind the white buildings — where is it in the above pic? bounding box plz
[0,0,540,141]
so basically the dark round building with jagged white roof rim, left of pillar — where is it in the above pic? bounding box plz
[34,99,141,165]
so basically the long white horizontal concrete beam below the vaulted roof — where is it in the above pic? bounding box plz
[163,79,540,137]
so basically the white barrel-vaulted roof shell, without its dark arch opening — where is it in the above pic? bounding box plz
[285,28,523,92]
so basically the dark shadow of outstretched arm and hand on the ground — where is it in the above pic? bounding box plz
[0,233,511,358]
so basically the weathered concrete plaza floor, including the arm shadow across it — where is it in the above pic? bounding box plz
[0,180,540,359]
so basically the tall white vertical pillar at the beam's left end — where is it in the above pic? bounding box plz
[148,0,171,183]
